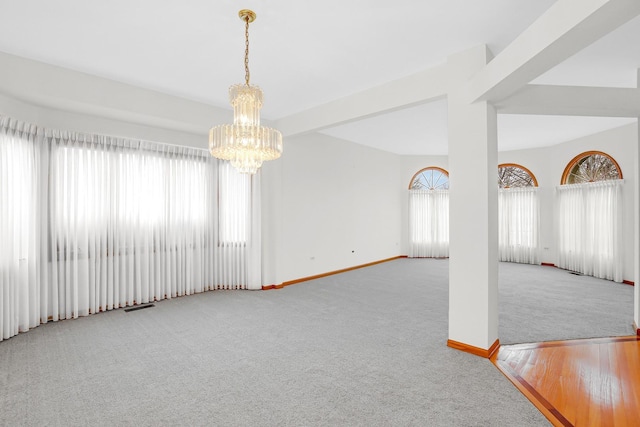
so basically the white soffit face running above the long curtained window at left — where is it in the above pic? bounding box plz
[0,52,233,140]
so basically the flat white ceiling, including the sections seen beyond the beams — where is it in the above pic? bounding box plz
[0,0,640,154]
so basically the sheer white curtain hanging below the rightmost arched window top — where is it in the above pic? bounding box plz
[556,180,623,282]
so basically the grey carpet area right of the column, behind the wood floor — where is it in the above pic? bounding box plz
[499,262,635,344]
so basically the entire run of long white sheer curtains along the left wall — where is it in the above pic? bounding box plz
[0,118,262,340]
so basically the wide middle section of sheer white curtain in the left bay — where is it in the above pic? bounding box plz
[45,131,222,320]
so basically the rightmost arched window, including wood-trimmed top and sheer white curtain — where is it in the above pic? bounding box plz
[556,151,624,282]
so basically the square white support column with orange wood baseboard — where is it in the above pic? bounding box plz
[447,50,498,357]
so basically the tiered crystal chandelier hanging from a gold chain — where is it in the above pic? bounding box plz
[209,9,282,174]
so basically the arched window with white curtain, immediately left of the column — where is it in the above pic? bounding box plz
[409,166,449,258]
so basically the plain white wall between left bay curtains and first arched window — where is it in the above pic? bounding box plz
[263,133,405,284]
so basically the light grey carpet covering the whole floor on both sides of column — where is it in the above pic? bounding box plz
[0,259,632,426]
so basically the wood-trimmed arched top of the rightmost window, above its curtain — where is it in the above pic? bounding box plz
[560,151,622,184]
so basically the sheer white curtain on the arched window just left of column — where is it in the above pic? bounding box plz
[409,190,449,258]
